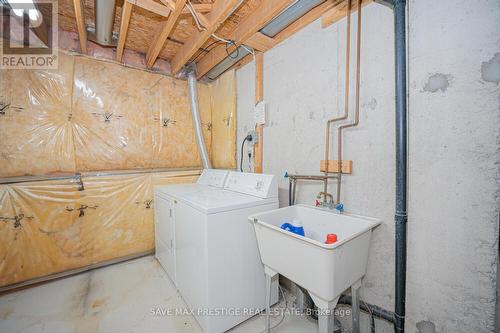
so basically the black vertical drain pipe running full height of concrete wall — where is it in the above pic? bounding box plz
[393,0,408,333]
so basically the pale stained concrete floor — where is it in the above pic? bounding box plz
[0,256,317,333]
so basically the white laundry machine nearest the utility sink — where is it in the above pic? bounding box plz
[168,172,278,333]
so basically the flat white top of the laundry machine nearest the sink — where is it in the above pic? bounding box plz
[178,188,278,214]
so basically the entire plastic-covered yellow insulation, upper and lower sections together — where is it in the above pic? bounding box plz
[0,52,236,289]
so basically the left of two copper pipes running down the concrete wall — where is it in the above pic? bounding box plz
[323,0,351,203]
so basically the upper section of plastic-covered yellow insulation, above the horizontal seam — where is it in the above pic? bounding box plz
[0,53,212,177]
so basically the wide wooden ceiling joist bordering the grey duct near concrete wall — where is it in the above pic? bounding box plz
[197,0,293,77]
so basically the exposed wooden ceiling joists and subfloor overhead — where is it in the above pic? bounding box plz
[59,0,362,78]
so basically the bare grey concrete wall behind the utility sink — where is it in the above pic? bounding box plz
[237,0,500,333]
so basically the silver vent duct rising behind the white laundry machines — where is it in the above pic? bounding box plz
[185,63,212,169]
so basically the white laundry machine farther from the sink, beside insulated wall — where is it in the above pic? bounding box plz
[154,169,229,285]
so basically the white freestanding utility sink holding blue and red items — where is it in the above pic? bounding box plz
[249,205,381,333]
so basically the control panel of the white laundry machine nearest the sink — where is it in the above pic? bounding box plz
[224,172,278,198]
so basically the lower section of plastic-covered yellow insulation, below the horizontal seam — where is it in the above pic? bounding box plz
[0,172,197,286]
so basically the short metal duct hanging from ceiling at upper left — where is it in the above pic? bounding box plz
[88,0,116,46]
